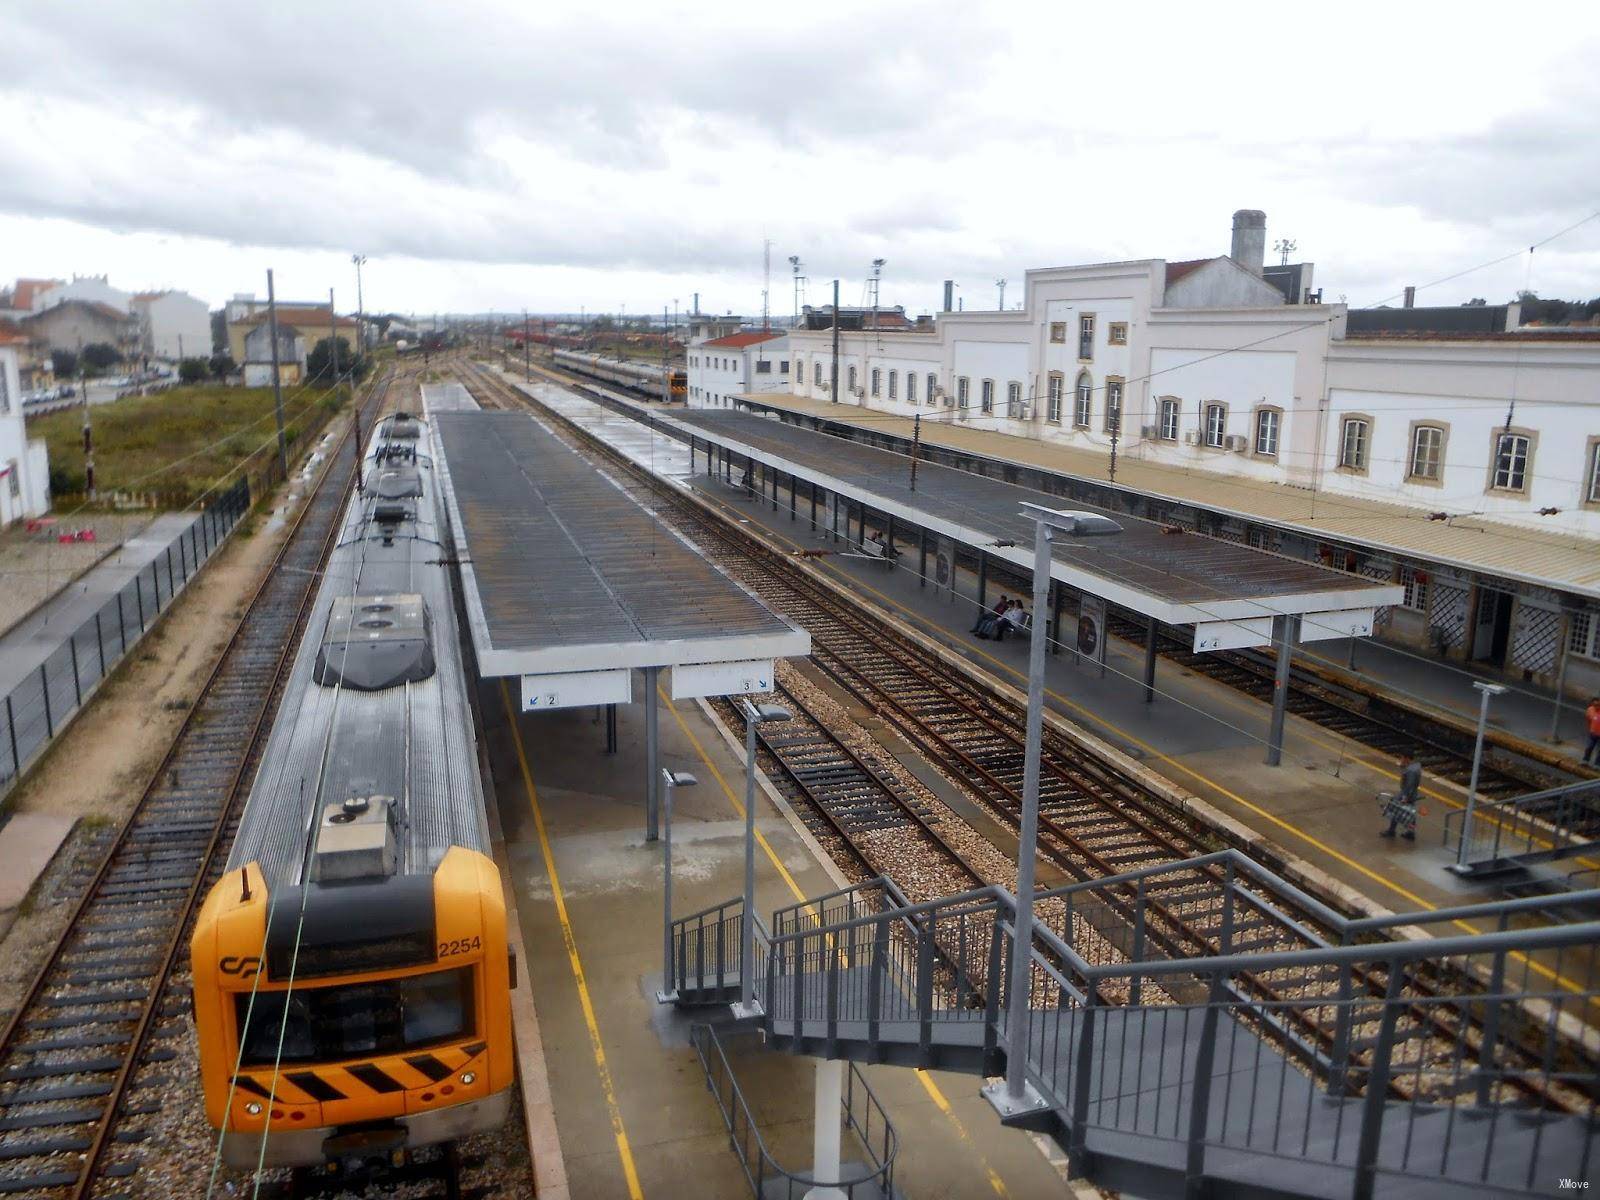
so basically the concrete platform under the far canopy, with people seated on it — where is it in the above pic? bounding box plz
[508,371,1582,912]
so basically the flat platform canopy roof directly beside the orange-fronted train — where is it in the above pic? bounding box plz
[429,406,811,709]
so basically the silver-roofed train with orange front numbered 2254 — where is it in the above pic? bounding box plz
[192,413,515,1168]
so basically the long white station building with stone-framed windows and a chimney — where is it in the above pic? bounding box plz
[690,210,1600,694]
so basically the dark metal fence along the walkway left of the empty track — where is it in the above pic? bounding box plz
[0,478,250,795]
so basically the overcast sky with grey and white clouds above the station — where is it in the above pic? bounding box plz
[0,0,1600,321]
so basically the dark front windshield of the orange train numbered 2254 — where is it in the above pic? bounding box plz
[234,968,472,1067]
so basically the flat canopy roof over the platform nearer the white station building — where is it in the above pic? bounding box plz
[653,410,1403,650]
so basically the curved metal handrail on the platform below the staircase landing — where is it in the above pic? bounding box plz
[690,1026,899,1198]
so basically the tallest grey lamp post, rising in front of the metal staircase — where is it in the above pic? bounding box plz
[984,502,1122,1115]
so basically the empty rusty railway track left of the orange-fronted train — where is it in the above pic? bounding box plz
[0,376,392,1200]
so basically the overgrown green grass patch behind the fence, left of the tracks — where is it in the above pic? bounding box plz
[27,384,349,507]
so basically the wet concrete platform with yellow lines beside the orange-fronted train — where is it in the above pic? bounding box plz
[482,682,1067,1200]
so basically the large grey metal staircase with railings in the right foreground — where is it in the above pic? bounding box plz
[674,851,1600,1198]
